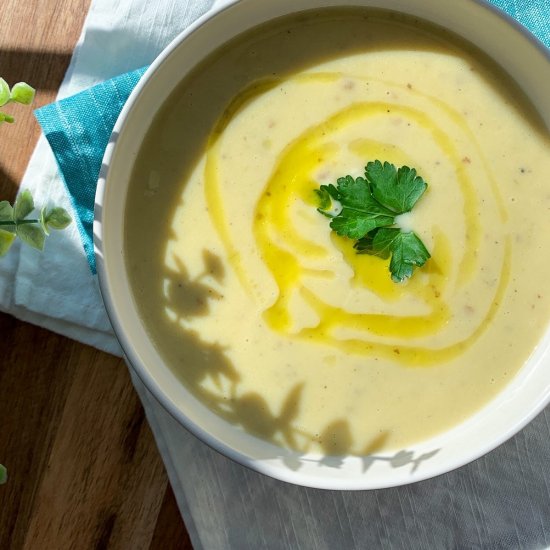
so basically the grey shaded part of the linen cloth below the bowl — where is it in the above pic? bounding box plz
[133,375,550,550]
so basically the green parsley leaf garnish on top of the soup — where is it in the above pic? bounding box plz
[316,160,430,282]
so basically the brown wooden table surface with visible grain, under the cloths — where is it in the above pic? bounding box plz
[0,0,191,550]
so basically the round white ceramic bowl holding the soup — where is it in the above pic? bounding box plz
[94,0,550,489]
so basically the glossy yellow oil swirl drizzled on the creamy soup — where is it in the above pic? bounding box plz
[205,73,511,365]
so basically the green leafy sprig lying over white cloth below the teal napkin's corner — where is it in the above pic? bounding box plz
[0,189,72,257]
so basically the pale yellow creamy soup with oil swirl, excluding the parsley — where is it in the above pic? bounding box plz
[125,10,550,454]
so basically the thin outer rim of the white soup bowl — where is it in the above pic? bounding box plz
[93,0,550,490]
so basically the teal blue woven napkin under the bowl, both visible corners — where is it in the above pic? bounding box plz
[35,0,550,273]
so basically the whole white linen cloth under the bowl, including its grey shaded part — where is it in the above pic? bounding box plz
[0,0,550,550]
